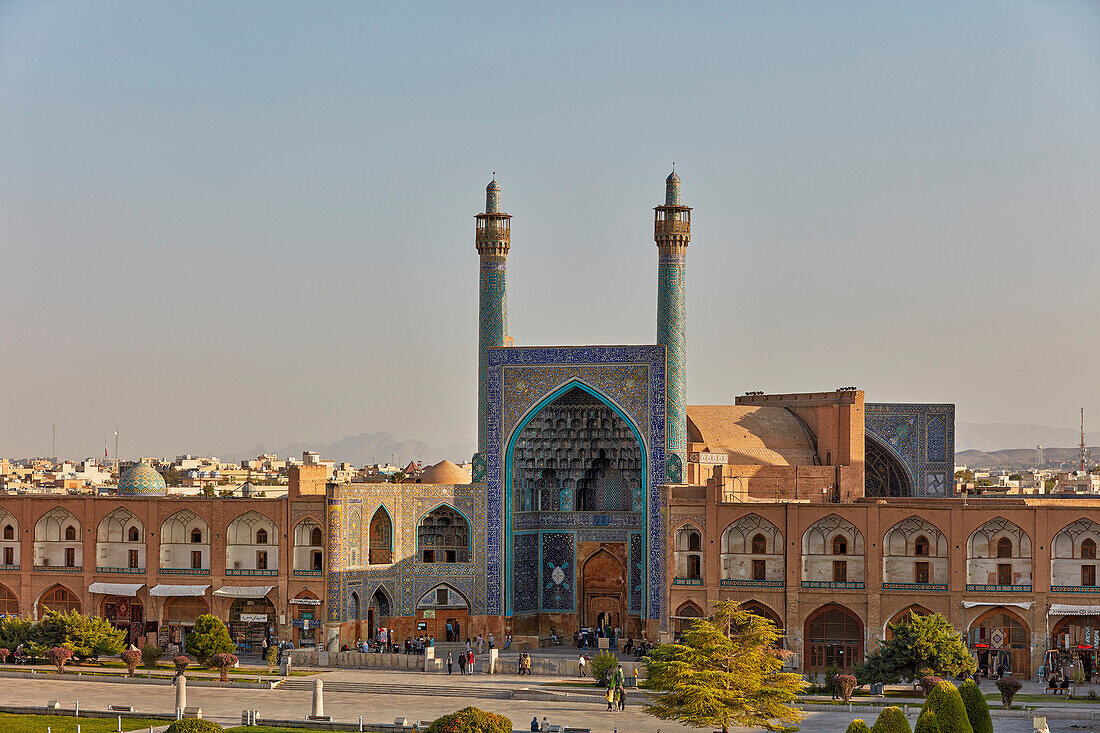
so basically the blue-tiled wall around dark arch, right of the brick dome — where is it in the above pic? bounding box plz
[864,402,955,496]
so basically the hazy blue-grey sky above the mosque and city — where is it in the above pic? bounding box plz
[0,0,1100,457]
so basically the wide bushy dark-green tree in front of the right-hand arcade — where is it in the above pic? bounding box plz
[857,613,975,683]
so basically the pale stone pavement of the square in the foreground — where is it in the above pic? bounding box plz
[0,670,1100,733]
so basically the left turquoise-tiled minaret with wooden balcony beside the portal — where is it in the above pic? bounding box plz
[474,175,512,456]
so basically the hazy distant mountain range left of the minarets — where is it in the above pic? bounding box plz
[220,433,477,466]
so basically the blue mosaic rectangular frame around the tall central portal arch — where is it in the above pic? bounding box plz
[484,346,666,620]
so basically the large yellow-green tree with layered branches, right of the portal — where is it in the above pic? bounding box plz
[644,601,805,732]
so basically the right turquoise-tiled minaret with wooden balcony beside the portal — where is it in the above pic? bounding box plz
[653,169,691,461]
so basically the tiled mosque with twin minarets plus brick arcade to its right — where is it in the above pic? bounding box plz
[327,172,1100,674]
